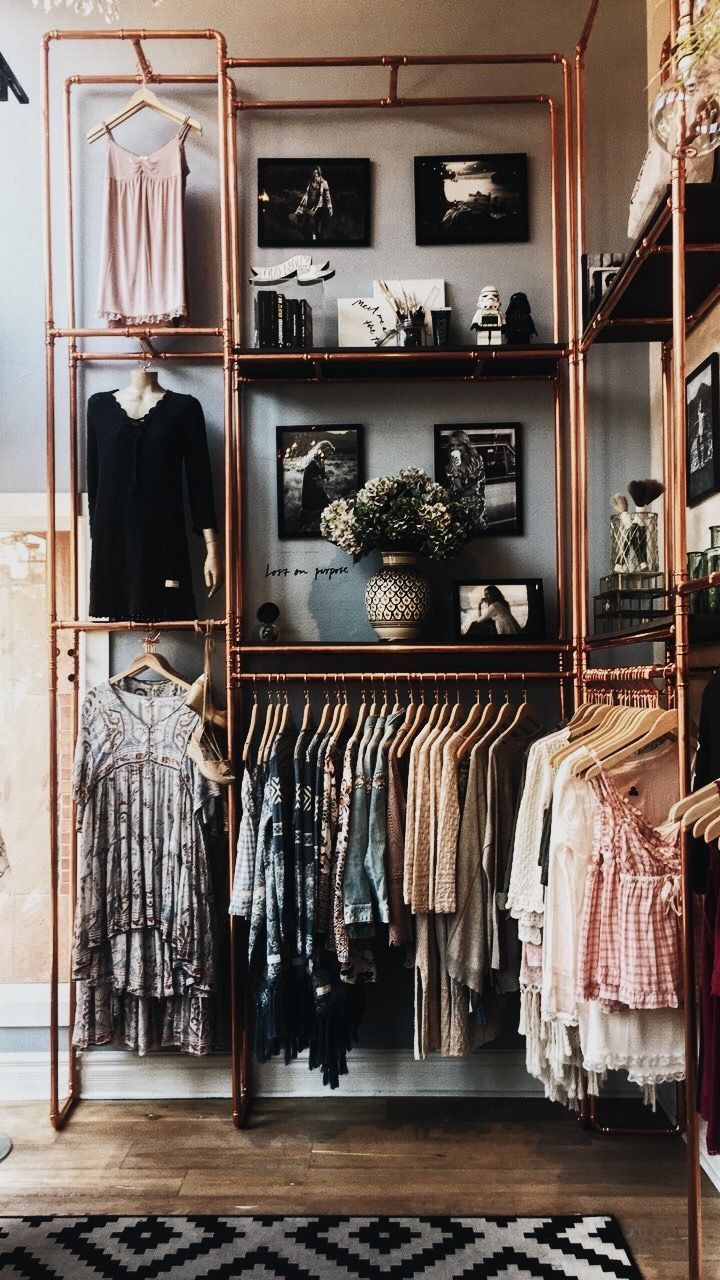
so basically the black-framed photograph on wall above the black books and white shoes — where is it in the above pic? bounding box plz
[258,157,370,248]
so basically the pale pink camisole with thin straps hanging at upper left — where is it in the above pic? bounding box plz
[97,122,188,325]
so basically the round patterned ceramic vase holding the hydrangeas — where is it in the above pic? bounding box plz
[365,552,432,644]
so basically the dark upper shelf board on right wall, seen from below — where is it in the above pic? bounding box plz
[583,183,720,347]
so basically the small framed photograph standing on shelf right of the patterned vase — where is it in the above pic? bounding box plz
[455,577,544,644]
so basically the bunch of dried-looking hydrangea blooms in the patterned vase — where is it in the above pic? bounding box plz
[320,467,477,561]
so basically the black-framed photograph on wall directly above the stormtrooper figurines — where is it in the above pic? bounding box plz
[415,151,529,244]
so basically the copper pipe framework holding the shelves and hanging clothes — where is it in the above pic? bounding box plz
[42,12,707,1280]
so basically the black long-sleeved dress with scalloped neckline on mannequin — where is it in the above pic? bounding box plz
[87,390,217,622]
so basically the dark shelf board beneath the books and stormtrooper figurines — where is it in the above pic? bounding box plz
[234,343,568,383]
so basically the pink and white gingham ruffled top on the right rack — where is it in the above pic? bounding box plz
[578,757,683,1011]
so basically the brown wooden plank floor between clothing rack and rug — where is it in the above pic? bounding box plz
[0,1097,720,1280]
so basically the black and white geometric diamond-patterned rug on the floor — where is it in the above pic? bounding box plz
[0,1215,642,1280]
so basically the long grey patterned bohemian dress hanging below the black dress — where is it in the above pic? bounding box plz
[73,677,223,1053]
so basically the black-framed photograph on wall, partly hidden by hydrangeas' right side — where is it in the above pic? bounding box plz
[434,422,523,536]
